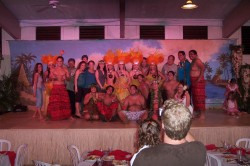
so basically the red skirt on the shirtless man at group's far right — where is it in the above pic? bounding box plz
[191,77,206,111]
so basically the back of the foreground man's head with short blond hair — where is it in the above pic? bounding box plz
[161,100,192,140]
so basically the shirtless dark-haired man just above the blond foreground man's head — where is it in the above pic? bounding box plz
[162,71,179,101]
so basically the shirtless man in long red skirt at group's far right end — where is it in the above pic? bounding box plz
[189,50,206,119]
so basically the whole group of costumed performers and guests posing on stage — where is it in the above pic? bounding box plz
[33,50,229,123]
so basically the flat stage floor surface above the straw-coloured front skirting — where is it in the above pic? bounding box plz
[0,110,250,129]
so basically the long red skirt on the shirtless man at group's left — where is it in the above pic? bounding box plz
[47,85,71,120]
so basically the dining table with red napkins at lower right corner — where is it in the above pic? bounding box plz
[206,145,250,166]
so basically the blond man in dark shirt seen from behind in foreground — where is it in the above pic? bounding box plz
[133,100,206,166]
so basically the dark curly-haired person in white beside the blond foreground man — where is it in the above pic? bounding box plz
[130,120,161,165]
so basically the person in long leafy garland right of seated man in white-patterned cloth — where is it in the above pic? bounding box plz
[147,81,163,121]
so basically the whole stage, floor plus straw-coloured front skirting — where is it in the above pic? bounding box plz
[0,110,250,165]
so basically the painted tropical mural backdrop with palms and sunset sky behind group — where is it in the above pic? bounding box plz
[9,40,235,106]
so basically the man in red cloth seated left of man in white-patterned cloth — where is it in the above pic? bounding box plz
[97,85,119,122]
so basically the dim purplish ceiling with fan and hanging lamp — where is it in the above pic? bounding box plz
[0,0,241,20]
